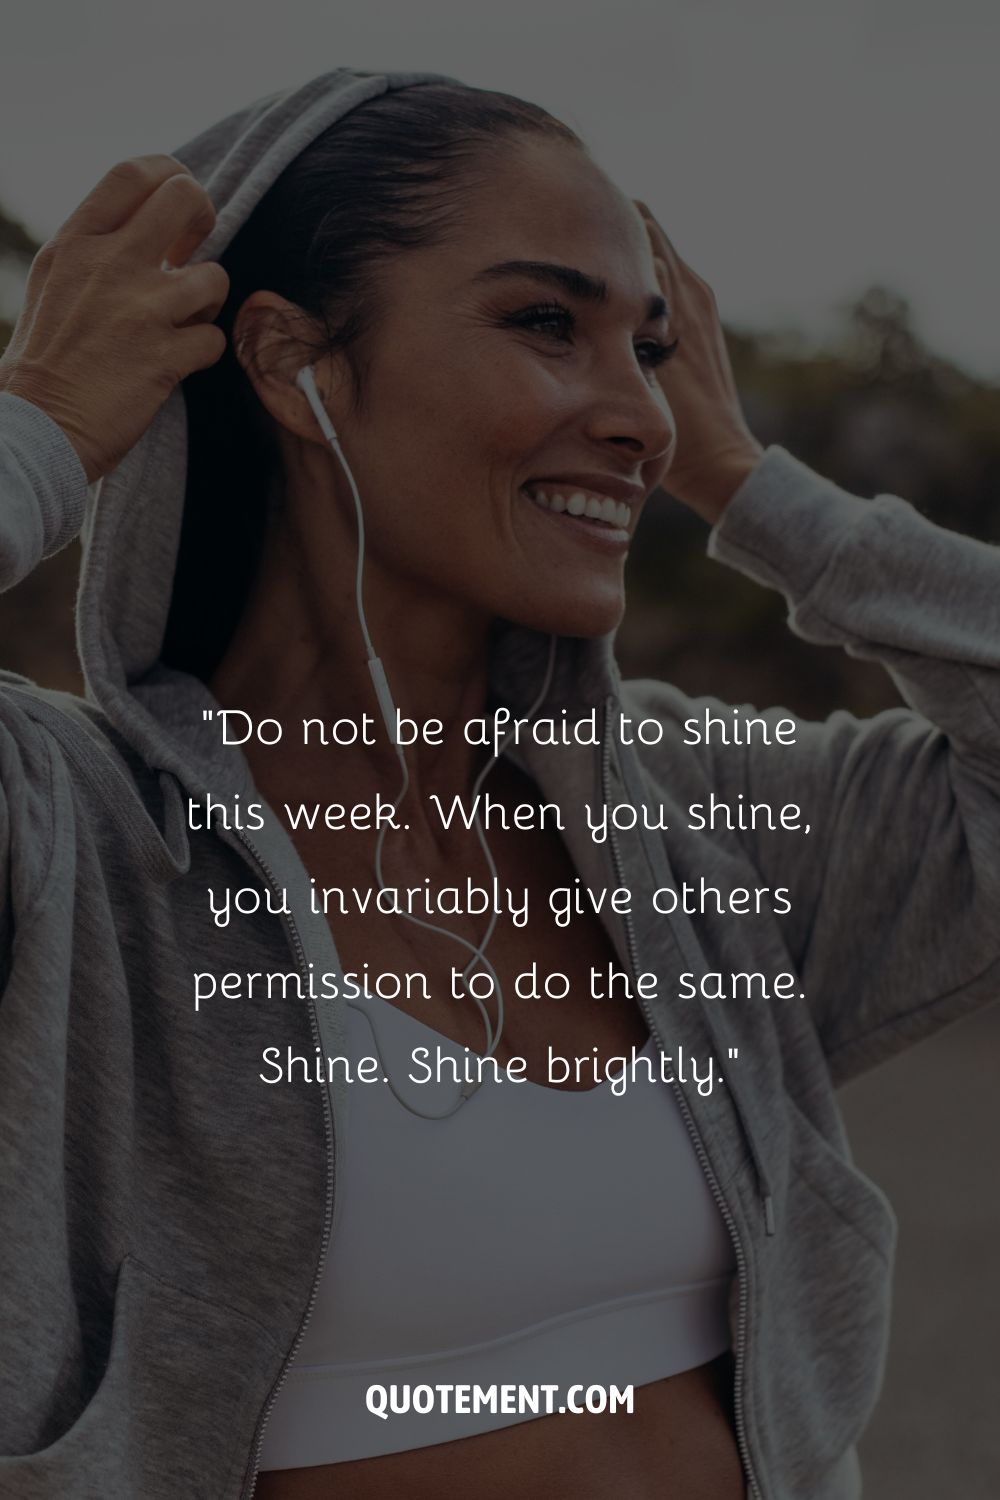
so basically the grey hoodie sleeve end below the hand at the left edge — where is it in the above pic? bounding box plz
[0,392,87,593]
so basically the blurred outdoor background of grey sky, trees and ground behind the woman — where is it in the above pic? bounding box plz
[0,0,1000,1500]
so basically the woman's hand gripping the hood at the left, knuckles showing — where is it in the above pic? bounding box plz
[0,156,229,482]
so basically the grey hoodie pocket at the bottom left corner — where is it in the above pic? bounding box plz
[0,1256,282,1500]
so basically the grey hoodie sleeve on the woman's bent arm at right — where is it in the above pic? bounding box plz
[656,449,1000,1082]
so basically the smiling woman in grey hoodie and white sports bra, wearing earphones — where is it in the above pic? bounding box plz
[0,71,1000,1500]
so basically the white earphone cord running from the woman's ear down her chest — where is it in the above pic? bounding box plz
[295,365,556,1119]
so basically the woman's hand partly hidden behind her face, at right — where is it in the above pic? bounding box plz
[634,198,763,525]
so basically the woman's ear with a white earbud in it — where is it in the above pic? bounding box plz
[232,291,342,444]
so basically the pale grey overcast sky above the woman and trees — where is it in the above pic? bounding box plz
[0,0,1000,378]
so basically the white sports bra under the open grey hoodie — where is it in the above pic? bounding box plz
[261,996,735,1470]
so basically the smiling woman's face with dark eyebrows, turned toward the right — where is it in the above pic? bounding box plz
[320,137,675,636]
